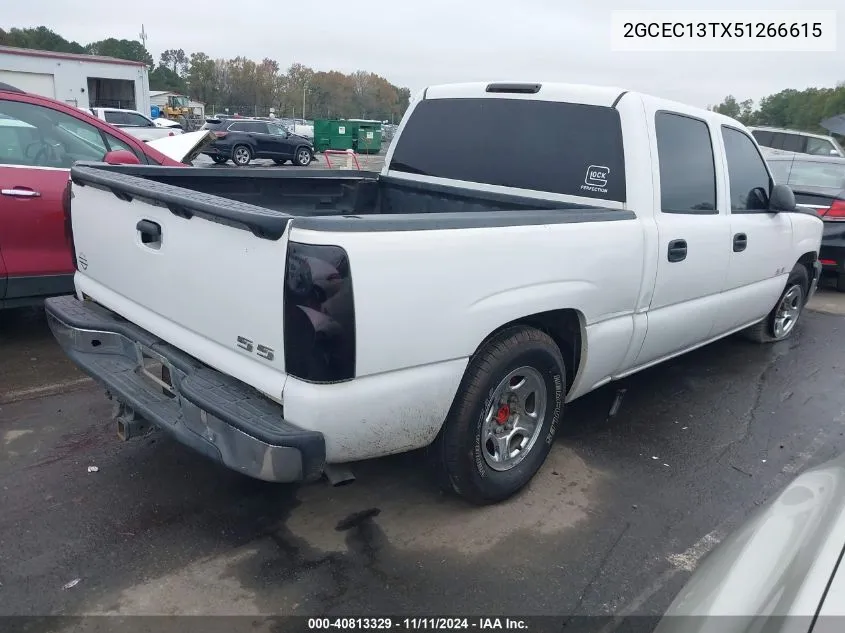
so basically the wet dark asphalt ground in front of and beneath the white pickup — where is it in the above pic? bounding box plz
[0,291,845,628]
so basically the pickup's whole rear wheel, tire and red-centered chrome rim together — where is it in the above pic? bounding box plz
[431,326,566,504]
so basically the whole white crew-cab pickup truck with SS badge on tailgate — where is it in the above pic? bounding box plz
[47,83,822,503]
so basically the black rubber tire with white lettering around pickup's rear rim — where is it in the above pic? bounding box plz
[430,326,566,505]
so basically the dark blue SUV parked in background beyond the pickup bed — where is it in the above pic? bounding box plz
[203,119,314,167]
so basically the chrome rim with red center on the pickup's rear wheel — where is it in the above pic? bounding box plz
[481,366,548,472]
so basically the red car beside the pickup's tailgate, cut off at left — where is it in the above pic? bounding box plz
[0,83,185,308]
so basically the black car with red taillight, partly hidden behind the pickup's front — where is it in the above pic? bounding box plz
[766,154,845,292]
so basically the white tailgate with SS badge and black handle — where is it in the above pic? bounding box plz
[71,165,290,399]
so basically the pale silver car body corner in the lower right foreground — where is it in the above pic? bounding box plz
[654,456,845,633]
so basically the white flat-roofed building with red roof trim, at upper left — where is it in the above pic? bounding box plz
[0,46,150,115]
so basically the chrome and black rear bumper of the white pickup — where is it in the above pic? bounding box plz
[45,297,326,482]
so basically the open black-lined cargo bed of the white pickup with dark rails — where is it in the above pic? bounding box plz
[71,163,634,239]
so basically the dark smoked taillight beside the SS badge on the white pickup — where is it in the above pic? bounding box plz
[284,242,355,382]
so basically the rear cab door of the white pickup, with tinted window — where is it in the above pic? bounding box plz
[636,107,730,366]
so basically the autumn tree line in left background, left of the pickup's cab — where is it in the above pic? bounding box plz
[0,26,411,122]
